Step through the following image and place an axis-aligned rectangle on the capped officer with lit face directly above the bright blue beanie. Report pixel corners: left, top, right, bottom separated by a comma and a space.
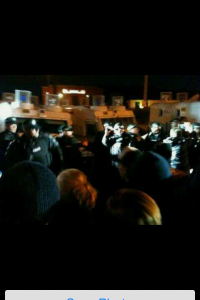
144, 122, 166, 151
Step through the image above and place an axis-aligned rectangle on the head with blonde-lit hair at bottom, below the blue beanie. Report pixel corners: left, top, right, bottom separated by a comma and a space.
106, 189, 162, 226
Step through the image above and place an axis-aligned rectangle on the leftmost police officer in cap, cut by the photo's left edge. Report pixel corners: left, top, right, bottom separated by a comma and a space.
0, 118, 18, 171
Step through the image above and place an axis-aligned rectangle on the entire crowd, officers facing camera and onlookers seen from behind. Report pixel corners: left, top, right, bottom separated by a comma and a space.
0, 118, 200, 228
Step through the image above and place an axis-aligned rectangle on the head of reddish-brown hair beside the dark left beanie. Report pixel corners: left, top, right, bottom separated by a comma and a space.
57, 169, 97, 210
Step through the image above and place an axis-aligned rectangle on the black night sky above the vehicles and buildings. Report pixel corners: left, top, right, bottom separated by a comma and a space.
0, 75, 200, 97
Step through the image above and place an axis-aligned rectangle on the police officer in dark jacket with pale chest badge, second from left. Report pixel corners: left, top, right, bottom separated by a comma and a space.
6, 119, 62, 175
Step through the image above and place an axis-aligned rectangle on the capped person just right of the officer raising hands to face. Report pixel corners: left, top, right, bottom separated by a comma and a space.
127, 124, 145, 151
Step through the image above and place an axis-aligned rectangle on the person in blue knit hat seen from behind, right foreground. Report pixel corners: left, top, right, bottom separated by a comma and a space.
127, 151, 173, 223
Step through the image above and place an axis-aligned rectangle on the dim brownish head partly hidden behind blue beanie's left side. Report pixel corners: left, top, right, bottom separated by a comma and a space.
118, 147, 142, 181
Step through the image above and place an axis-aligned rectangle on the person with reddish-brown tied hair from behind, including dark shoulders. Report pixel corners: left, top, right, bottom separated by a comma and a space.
45, 169, 97, 228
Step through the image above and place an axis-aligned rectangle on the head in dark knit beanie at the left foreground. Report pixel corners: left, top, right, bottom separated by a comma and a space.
0, 162, 60, 225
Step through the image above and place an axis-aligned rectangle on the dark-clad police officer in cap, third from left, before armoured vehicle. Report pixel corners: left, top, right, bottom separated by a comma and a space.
56, 125, 83, 170
